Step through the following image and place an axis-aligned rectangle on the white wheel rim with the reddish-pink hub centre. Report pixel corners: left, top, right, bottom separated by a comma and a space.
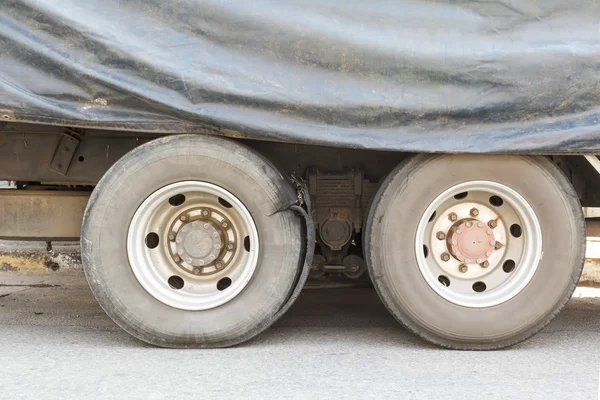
415, 181, 542, 308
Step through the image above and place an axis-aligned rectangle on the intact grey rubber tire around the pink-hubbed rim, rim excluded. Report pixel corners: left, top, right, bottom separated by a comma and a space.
364, 155, 585, 350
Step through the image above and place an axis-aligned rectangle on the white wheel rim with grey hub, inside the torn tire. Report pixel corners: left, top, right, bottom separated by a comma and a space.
127, 181, 259, 310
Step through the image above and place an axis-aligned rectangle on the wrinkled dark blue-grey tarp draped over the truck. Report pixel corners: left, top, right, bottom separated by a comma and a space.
0, 0, 600, 153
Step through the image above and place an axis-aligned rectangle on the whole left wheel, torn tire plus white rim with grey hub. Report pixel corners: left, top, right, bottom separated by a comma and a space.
81, 135, 305, 348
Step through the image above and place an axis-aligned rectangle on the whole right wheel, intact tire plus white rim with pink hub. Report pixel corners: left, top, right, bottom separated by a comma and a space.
364, 155, 585, 350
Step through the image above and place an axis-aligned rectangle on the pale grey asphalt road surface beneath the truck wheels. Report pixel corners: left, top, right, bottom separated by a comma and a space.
0, 273, 600, 400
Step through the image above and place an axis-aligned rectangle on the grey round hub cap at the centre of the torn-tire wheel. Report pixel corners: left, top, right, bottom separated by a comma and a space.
175, 221, 223, 266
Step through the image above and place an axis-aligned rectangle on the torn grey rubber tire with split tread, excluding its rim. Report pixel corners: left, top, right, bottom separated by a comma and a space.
81, 135, 304, 347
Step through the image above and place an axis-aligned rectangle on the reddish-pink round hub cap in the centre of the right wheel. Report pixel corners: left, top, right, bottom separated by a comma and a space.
446, 219, 496, 264
